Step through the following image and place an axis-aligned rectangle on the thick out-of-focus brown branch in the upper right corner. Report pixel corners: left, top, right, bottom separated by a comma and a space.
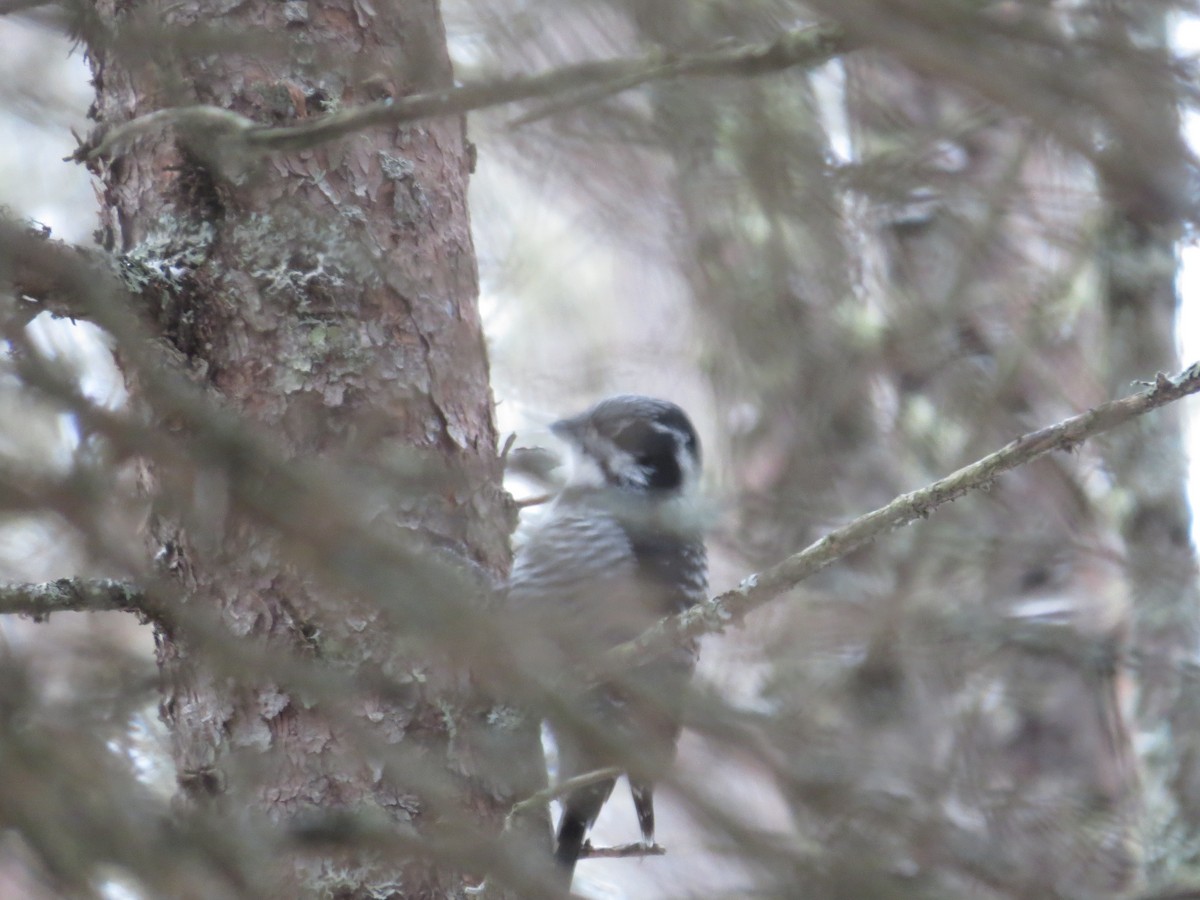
810, 0, 1196, 223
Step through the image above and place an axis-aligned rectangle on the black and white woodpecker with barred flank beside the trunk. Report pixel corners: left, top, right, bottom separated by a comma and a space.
509, 395, 708, 880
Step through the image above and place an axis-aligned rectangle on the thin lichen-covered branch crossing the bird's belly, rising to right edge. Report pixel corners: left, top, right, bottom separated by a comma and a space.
604, 362, 1200, 672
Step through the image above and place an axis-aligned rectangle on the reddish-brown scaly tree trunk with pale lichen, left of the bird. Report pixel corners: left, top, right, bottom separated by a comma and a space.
89, 0, 539, 898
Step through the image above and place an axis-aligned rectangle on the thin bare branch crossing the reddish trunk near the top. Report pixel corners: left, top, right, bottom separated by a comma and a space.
82, 26, 850, 162
